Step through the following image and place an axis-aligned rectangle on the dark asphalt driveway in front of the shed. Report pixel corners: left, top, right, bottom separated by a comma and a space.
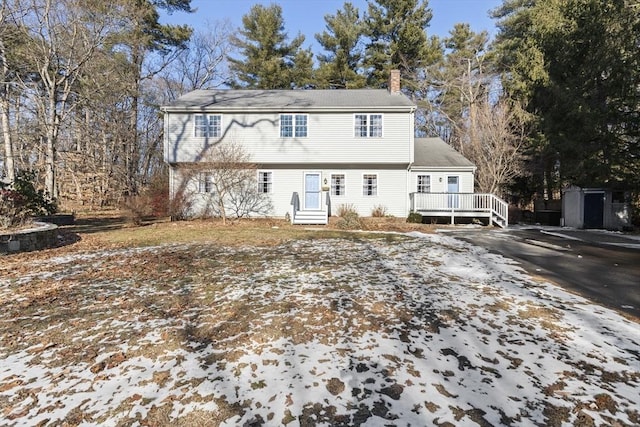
451, 226, 640, 317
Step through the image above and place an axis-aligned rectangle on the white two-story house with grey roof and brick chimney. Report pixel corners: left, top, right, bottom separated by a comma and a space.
162, 71, 506, 224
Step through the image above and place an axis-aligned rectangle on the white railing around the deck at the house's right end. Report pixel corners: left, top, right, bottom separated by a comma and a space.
410, 193, 509, 227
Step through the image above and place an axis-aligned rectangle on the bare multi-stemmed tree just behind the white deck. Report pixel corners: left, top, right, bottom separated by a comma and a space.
465, 99, 526, 197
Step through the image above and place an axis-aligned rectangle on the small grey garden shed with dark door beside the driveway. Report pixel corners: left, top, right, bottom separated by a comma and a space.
561, 186, 631, 230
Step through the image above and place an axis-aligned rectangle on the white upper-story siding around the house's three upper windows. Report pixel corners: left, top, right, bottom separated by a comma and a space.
165, 111, 413, 165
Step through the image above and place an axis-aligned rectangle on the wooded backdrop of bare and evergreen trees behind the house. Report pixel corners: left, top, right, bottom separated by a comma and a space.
0, 0, 640, 216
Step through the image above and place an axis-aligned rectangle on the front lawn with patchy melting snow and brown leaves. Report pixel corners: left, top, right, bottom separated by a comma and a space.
0, 234, 640, 426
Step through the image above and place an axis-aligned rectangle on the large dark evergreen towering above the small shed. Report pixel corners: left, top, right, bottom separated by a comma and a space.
495, 0, 640, 197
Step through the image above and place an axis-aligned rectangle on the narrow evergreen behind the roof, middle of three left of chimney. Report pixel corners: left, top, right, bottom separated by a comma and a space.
316, 2, 366, 89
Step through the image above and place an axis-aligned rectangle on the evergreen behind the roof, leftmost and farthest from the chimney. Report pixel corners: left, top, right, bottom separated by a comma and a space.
229, 4, 313, 89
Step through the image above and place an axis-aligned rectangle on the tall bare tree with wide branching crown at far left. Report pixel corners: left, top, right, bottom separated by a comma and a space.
13, 0, 116, 197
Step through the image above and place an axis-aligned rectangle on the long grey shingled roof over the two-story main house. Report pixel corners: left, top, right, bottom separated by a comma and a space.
162, 89, 415, 112
